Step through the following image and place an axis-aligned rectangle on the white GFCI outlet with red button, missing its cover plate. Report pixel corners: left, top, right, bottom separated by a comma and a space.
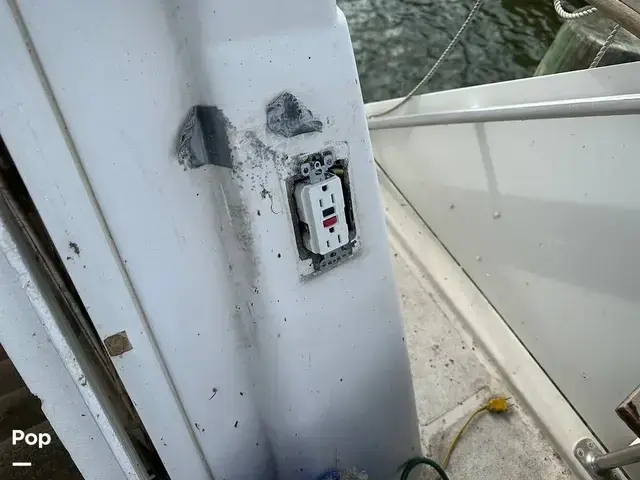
295, 175, 349, 255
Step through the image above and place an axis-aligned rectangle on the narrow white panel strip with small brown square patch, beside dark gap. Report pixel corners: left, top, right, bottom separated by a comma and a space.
0, 3, 222, 479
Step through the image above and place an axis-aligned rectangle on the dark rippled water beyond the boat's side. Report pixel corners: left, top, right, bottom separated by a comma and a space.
338, 0, 572, 102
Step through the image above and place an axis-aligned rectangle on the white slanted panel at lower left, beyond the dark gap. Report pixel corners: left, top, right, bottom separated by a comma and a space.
0, 200, 148, 480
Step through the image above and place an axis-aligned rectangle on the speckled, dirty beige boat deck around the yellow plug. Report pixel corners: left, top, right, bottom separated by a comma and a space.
382, 172, 576, 480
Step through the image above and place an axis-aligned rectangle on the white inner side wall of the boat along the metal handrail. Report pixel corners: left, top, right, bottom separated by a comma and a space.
371, 60, 640, 468
